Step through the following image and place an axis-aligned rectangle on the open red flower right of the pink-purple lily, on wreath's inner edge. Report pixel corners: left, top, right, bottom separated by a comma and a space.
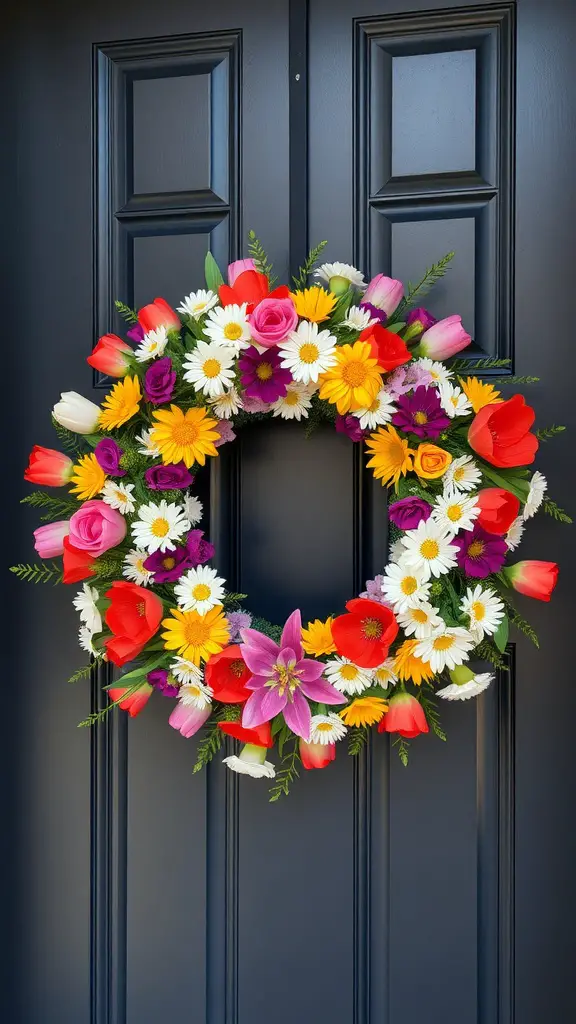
332, 597, 398, 669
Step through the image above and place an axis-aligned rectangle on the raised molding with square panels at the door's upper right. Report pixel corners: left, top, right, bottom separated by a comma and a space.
354, 3, 516, 375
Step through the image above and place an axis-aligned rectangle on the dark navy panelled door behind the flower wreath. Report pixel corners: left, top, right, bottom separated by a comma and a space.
0, 0, 576, 1024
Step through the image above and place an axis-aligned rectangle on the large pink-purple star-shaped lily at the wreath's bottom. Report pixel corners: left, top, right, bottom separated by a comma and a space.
240, 609, 346, 741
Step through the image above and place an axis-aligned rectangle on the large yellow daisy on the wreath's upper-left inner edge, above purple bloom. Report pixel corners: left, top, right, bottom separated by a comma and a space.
151, 406, 220, 469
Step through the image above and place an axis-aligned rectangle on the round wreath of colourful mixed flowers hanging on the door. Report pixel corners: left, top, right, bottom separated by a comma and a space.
12, 239, 571, 800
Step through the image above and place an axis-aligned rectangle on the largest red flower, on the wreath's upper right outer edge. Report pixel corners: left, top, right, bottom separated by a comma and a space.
468, 394, 538, 469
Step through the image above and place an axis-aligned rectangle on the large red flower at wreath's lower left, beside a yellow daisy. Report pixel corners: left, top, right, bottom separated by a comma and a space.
105, 581, 163, 666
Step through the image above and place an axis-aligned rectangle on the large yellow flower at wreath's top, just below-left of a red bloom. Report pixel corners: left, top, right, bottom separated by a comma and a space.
320, 341, 382, 416
